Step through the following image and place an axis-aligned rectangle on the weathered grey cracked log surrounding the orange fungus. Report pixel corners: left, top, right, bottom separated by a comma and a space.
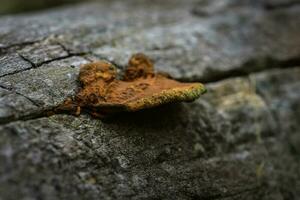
0, 0, 300, 200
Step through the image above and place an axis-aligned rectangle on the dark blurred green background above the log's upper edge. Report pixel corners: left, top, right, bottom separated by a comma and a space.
0, 0, 87, 15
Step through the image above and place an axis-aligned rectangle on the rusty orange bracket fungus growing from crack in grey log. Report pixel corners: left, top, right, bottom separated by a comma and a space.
58, 53, 206, 117
